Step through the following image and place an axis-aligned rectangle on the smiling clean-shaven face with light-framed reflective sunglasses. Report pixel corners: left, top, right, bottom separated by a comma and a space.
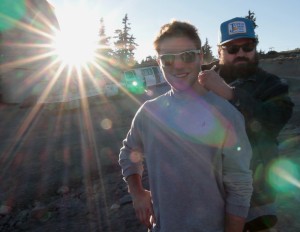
158, 37, 201, 91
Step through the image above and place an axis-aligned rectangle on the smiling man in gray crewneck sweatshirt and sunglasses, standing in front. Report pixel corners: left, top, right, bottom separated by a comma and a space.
119, 21, 252, 232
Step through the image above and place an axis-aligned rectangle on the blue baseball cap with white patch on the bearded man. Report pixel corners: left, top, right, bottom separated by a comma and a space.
218, 17, 256, 45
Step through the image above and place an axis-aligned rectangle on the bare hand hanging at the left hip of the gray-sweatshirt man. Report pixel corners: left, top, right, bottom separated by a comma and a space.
132, 190, 156, 228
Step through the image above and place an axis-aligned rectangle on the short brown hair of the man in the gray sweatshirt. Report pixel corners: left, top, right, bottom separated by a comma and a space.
153, 20, 201, 52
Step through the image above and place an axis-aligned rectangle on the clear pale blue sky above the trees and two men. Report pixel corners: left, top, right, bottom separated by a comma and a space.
48, 0, 300, 61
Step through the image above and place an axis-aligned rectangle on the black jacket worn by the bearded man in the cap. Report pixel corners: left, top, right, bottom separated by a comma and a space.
202, 62, 294, 207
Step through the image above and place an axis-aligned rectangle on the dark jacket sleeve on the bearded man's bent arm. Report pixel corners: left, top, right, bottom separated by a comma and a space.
231, 76, 294, 137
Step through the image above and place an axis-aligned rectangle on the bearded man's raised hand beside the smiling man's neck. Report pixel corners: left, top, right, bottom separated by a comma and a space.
198, 66, 233, 100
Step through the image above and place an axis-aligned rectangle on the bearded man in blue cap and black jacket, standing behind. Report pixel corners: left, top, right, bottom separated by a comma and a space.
198, 18, 294, 232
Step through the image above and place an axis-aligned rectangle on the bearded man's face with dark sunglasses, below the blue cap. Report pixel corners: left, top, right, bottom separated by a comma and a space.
218, 39, 256, 67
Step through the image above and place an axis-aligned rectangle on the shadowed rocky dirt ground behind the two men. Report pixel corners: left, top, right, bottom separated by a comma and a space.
0, 77, 300, 232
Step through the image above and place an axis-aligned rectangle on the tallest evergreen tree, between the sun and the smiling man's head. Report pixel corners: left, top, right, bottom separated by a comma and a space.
114, 14, 138, 68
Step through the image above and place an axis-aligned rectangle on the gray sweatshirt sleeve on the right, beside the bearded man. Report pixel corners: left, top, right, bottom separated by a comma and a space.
223, 111, 253, 217
